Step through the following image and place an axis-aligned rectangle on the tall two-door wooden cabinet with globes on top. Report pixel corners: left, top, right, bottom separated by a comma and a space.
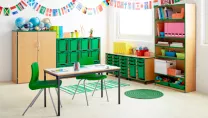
12, 31, 56, 84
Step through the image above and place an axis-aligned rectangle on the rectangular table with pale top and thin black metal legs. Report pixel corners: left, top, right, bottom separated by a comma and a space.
44, 64, 121, 116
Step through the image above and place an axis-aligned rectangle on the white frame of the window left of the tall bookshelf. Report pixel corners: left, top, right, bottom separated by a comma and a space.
115, 8, 155, 42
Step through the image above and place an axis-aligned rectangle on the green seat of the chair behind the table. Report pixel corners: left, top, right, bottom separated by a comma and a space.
76, 74, 107, 80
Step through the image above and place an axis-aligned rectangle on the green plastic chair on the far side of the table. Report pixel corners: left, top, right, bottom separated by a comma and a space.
72, 57, 109, 106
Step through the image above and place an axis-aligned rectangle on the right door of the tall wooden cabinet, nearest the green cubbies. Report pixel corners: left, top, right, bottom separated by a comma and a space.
38, 32, 56, 80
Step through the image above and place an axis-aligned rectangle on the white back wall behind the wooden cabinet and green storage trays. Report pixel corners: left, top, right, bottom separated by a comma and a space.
0, 0, 107, 81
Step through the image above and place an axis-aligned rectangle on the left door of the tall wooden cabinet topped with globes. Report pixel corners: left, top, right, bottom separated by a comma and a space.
18, 32, 37, 83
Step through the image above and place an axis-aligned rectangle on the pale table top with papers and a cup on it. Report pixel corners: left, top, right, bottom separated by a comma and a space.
44, 64, 120, 77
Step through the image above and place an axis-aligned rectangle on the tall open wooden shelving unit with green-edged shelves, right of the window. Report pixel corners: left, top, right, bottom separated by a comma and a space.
154, 4, 196, 92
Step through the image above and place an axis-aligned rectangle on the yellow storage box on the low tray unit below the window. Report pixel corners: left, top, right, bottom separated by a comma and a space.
113, 42, 132, 54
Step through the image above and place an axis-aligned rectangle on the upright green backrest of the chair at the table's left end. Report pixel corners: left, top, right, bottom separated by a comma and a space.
29, 62, 39, 89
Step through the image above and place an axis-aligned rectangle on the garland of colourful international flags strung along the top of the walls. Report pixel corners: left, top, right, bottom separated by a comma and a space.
0, 0, 184, 17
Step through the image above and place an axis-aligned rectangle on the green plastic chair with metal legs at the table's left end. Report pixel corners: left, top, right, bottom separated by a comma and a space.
22, 62, 62, 116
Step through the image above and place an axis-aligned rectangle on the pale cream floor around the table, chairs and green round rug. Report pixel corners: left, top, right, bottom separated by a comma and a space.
0, 77, 208, 118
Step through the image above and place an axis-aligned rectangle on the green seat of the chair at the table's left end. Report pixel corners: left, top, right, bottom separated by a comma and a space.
29, 80, 62, 90
